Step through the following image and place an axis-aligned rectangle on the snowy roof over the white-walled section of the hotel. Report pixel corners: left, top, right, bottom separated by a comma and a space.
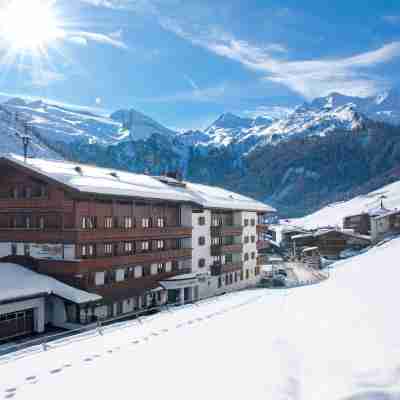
181, 182, 276, 212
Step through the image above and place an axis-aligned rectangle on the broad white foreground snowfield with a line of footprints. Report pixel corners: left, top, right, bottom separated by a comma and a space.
0, 239, 400, 400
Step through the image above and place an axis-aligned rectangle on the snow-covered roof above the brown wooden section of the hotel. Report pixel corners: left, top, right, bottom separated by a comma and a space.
1, 154, 194, 202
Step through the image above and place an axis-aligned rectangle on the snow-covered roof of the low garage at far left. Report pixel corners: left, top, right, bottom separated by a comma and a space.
0, 263, 101, 304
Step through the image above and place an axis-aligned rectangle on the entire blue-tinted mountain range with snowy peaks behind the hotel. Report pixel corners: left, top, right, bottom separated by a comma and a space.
0, 90, 400, 216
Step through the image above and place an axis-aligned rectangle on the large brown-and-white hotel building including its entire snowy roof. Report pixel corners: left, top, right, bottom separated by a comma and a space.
0, 155, 274, 332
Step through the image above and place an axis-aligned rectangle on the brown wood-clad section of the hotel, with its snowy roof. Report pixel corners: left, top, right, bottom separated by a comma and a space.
0, 156, 197, 323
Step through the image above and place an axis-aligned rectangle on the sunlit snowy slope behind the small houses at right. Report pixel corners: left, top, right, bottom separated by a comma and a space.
291, 181, 400, 229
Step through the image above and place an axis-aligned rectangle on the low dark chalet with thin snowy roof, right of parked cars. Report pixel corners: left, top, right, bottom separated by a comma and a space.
292, 229, 371, 259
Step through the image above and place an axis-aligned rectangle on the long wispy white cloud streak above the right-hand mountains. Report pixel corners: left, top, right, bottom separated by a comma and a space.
160, 18, 400, 98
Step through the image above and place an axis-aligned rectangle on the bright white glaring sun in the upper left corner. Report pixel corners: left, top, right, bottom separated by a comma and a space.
0, 0, 62, 52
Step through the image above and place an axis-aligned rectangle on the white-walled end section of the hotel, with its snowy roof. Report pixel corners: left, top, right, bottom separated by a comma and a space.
154, 177, 276, 298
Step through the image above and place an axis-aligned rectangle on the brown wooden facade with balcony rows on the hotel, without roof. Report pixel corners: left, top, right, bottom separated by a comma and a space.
0, 160, 192, 320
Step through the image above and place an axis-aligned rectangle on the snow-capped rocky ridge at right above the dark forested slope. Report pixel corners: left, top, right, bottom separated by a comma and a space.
182, 89, 400, 152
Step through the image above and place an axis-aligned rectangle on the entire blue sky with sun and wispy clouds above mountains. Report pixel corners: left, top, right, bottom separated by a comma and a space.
0, 0, 400, 129
